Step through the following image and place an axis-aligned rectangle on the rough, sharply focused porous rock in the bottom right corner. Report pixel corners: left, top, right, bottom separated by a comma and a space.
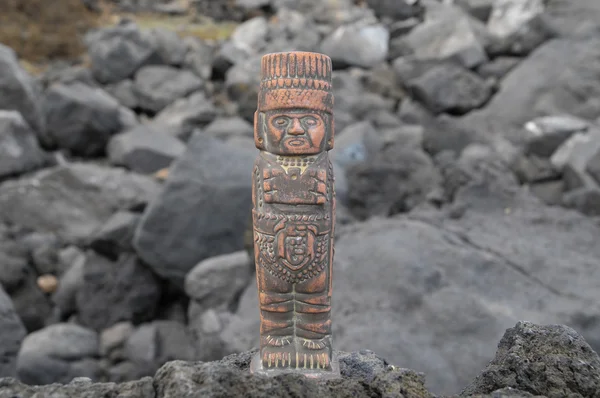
461, 322, 600, 398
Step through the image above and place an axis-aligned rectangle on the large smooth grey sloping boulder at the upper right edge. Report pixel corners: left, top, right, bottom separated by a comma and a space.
465, 35, 600, 134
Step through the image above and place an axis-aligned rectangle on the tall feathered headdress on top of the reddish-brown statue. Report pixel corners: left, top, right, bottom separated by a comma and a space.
258, 52, 333, 113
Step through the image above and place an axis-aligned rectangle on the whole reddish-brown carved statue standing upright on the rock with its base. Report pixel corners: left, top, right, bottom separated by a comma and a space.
251, 52, 339, 378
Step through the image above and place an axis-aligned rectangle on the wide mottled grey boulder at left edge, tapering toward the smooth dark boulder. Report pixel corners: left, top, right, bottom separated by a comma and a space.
0, 163, 160, 242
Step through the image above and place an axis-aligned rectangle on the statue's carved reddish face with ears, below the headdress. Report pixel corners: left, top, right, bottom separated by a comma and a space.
259, 110, 329, 155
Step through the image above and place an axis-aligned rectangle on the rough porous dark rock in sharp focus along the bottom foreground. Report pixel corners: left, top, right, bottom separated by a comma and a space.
0, 322, 600, 398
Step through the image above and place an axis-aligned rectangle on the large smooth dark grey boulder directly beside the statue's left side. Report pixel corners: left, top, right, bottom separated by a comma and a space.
134, 132, 256, 287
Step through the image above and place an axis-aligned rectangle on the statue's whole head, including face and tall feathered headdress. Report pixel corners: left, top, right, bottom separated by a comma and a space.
254, 52, 334, 155
